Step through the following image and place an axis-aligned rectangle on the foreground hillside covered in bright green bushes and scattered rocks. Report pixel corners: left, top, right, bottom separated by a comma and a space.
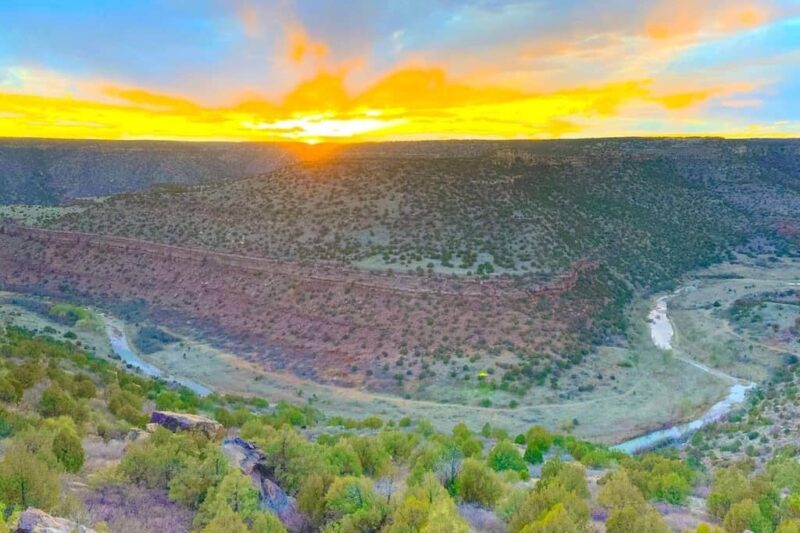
0, 304, 800, 533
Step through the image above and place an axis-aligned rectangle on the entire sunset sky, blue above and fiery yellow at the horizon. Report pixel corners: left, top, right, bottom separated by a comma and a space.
0, 0, 800, 143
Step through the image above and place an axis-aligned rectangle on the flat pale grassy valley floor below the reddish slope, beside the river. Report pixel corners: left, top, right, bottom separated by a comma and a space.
0, 286, 724, 444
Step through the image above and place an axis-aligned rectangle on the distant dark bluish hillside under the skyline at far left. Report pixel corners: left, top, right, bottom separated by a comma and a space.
0, 139, 290, 205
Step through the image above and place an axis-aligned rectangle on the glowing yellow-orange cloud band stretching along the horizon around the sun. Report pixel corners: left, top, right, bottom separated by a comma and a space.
0, 63, 768, 143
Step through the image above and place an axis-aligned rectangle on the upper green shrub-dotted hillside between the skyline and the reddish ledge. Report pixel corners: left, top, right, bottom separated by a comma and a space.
56, 139, 800, 287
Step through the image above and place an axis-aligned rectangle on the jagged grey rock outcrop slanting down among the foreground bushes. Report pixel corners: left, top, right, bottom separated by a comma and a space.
222, 437, 305, 531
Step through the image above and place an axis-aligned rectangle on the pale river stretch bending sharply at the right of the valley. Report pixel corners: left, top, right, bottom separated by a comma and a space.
613, 290, 755, 454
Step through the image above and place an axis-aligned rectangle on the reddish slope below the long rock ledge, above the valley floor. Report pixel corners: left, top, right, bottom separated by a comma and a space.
0, 226, 597, 390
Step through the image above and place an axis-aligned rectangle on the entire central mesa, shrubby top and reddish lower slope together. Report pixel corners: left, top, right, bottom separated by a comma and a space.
0, 139, 800, 405
